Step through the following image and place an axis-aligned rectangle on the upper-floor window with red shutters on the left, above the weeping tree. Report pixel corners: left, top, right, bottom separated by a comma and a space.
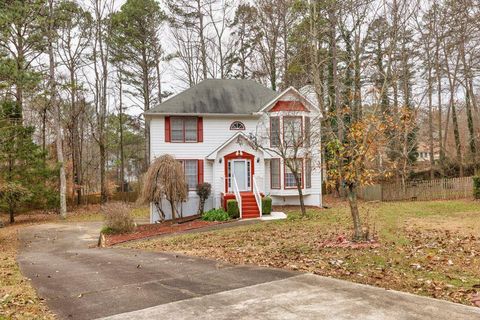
165, 117, 203, 142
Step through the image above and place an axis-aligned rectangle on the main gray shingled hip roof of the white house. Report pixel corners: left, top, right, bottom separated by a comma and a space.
145, 79, 279, 115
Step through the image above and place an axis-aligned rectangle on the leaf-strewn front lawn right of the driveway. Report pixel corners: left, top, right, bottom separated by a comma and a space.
126, 200, 480, 304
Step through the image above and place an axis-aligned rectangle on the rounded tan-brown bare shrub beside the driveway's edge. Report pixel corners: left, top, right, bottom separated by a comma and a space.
102, 202, 135, 234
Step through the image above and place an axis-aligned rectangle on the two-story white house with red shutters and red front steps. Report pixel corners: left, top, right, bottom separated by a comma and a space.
145, 80, 322, 222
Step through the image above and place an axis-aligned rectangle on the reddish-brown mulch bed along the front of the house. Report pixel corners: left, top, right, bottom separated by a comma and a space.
105, 219, 222, 246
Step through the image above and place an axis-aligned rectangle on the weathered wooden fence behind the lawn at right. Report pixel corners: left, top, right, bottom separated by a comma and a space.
358, 177, 473, 201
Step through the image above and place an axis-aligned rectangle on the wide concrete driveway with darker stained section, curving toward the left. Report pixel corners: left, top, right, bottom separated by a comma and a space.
18, 223, 480, 320
